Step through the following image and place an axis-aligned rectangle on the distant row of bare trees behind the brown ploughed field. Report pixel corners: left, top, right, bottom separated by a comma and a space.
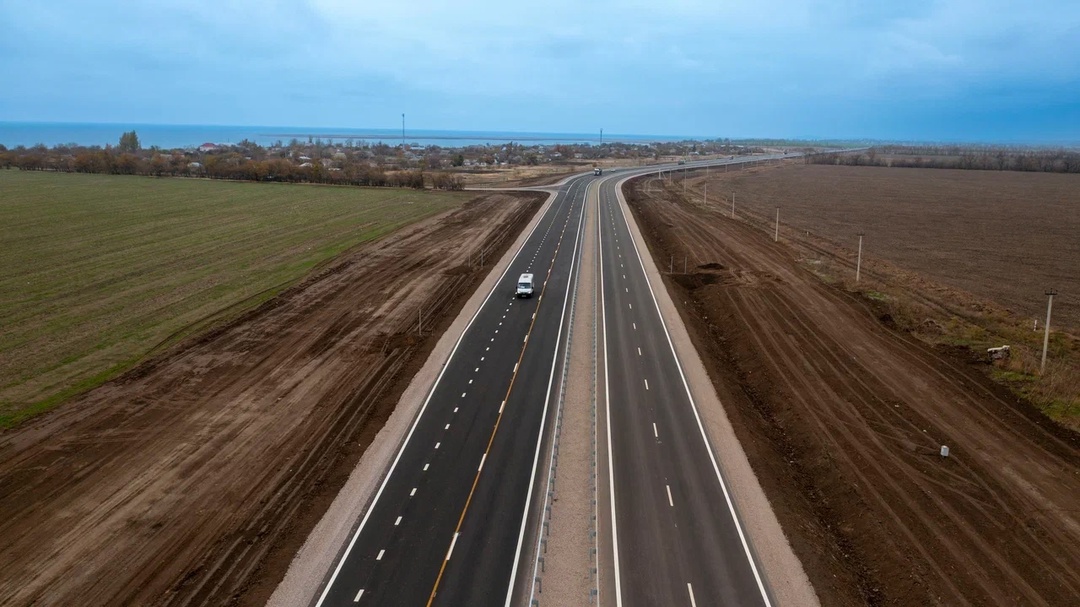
805, 146, 1080, 173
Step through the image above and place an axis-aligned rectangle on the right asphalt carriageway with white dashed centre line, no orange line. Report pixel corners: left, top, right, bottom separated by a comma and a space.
598, 171, 770, 606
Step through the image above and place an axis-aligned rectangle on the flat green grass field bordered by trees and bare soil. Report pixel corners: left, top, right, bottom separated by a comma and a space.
0, 170, 470, 428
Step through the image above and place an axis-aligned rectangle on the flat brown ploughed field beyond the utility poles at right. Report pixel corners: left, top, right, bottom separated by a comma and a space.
676, 164, 1080, 332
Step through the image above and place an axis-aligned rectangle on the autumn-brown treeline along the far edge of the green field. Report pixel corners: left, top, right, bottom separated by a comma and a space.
0, 146, 464, 190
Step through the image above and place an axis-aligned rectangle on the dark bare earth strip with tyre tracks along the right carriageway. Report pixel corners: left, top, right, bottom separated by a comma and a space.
627, 181, 1080, 606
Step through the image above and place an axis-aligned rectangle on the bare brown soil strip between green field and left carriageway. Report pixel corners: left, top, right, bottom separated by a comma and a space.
0, 193, 545, 605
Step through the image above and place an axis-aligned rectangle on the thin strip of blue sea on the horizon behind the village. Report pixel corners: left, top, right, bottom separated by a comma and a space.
0, 122, 686, 149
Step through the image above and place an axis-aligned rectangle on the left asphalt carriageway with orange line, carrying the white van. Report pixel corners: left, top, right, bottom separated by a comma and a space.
318, 171, 594, 606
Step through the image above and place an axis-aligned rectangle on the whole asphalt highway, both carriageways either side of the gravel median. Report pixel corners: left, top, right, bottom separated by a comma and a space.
315, 157, 790, 606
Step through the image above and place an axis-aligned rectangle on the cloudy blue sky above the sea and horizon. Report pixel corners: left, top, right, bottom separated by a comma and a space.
0, 0, 1080, 145
